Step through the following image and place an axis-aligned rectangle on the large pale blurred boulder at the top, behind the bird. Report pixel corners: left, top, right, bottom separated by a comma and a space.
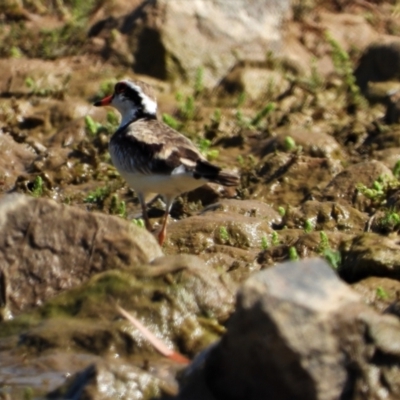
90, 0, 290, 87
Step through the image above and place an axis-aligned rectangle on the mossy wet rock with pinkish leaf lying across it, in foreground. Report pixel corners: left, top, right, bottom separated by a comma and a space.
0, 255, 236, 358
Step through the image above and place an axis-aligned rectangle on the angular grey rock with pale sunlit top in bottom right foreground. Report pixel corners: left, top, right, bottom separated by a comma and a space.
206, 259, 359, 400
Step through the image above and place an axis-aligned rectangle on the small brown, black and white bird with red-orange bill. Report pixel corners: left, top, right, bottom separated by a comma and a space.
94, 79, 239, 245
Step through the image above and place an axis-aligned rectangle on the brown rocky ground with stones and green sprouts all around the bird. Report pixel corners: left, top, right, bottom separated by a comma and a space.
0, 0, 400, 399
